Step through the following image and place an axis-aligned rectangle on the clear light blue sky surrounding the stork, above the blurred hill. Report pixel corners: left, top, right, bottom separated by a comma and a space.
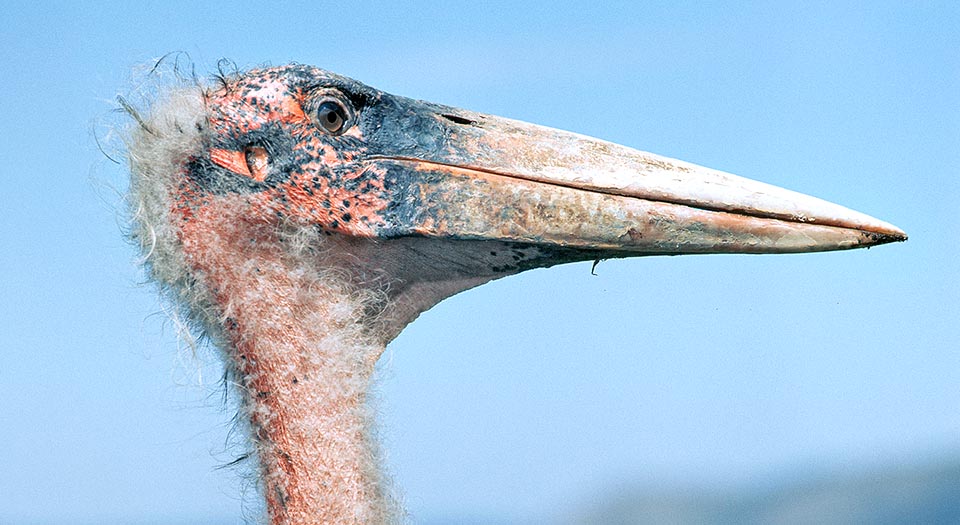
0, 1, 960, 523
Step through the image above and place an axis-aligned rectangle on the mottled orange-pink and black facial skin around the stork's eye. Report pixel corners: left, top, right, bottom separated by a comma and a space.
181, 68, 388, 237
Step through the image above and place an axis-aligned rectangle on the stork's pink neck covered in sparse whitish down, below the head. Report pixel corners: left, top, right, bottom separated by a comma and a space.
182, 203, 394, 524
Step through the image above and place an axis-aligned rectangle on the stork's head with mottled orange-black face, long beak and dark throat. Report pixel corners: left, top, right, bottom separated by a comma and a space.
133, 65, 906, 339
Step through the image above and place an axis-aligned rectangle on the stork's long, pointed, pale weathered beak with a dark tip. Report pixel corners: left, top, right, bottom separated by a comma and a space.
367, 101, 907, 256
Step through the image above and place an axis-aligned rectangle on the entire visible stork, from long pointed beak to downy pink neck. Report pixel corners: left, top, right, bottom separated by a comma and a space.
130, 65, 905, 524
